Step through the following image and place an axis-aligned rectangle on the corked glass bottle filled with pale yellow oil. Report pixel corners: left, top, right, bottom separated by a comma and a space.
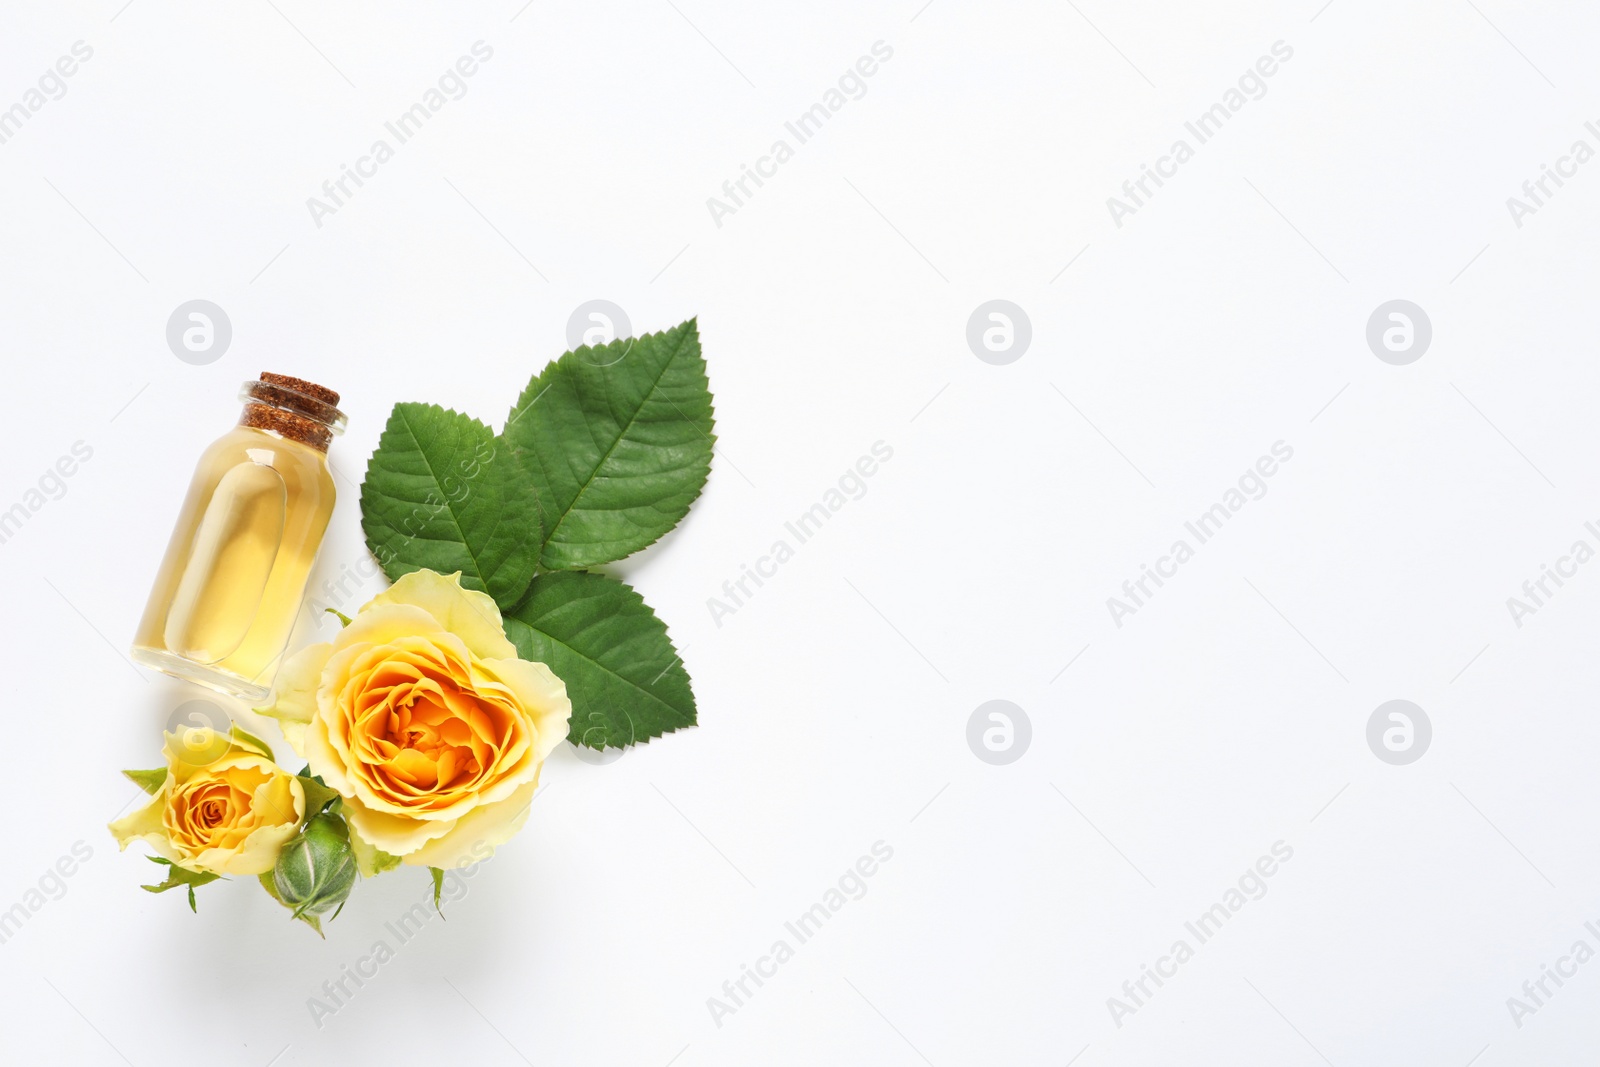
133, 374, 346, 702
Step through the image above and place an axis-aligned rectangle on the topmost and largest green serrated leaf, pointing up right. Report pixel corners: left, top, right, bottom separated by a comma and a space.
502, 318, 715, 571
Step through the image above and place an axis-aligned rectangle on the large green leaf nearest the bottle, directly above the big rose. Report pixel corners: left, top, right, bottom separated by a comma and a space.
362, 403, 542, 606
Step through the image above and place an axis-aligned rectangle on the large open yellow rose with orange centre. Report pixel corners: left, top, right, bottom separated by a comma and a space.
259, 569, 573, 869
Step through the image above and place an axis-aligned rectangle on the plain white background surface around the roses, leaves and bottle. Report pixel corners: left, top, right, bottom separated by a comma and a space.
0, 0, 1600, 1067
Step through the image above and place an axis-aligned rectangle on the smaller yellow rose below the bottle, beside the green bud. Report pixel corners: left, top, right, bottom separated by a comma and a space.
110, 726, 306, 875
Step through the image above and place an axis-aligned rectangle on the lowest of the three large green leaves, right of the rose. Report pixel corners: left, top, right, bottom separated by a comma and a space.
506, 571, 694, 749
